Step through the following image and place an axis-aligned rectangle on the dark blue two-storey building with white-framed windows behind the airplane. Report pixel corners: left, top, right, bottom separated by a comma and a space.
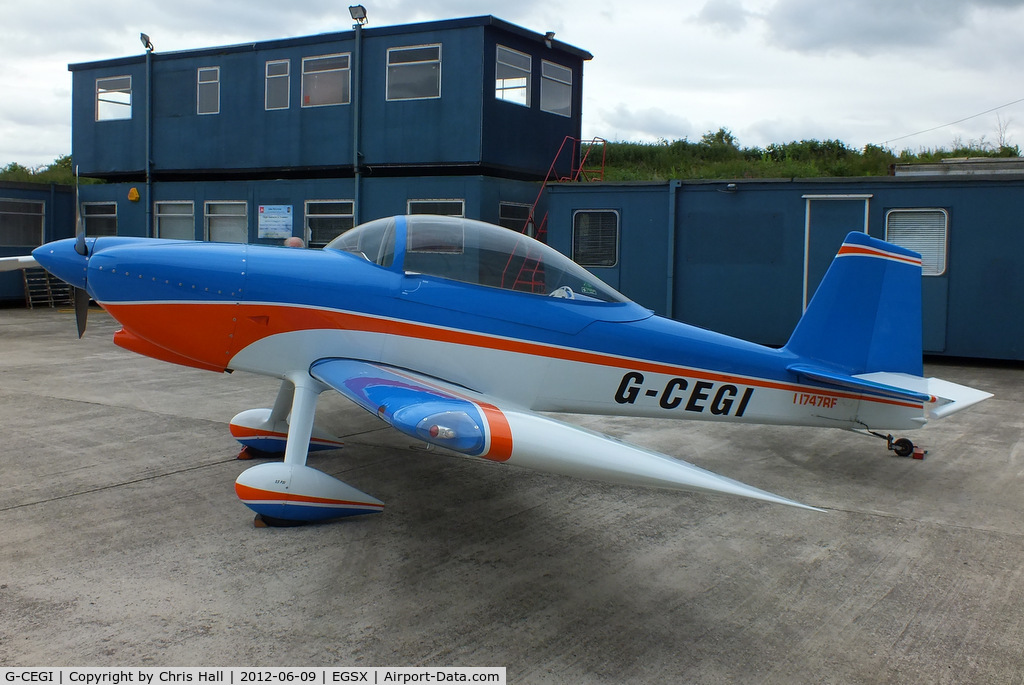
69, 16, 591, 246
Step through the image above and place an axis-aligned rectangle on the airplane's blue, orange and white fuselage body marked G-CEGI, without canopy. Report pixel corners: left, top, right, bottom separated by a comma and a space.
36, 239, 923, 429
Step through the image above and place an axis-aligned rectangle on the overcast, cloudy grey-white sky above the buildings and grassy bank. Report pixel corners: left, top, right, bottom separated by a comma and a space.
0, 0, 1024, 167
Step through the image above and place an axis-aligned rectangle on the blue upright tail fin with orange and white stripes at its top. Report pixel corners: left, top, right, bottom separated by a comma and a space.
785, 232, 923, 376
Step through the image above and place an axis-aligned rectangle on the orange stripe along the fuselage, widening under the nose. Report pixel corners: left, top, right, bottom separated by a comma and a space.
103, 301, 923, 411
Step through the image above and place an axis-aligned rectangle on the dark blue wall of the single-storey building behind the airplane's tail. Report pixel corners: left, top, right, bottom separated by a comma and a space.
549, 176, 1024, 360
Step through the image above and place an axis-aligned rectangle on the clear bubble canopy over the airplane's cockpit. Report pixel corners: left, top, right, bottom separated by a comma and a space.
324, 214, 629, 302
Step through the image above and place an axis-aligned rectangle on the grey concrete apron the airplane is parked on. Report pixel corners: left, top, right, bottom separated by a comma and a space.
0, 309, 1024, 683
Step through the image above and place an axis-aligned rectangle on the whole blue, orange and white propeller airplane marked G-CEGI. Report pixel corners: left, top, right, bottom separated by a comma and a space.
0, 215, 990, 524
